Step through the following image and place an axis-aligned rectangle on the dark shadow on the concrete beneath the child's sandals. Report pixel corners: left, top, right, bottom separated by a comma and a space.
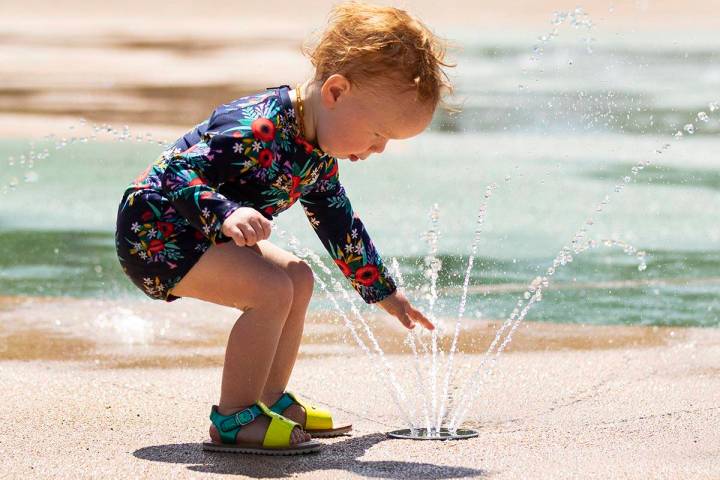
133, 433, 488, 480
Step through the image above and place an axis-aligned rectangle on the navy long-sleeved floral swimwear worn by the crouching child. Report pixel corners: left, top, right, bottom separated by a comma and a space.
115, 86, 395, 303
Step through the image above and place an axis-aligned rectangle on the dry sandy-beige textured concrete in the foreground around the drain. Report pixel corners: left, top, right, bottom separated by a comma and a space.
0, 320, 720, 479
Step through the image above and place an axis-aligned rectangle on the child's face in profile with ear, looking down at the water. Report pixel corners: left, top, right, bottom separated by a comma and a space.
317, 75, 434, 162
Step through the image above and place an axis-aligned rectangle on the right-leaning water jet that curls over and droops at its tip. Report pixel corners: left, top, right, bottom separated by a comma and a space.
448, 240, 647, 430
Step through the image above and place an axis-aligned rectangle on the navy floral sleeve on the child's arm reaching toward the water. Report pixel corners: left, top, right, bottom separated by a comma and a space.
300, 158, 396, 303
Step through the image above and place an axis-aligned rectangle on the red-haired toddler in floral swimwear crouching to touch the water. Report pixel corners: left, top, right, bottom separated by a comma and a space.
115, 2, 450, 454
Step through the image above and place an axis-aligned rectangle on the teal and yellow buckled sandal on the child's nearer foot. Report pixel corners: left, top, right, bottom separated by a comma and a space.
203, 402, 322, 455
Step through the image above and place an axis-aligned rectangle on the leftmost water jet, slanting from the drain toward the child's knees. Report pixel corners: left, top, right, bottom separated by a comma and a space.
275, 227, 416, 430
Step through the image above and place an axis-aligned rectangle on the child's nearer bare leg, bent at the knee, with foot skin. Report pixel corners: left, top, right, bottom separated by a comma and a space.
172, 243, 307, 442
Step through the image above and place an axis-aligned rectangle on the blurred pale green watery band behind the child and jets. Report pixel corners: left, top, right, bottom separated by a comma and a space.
0, 34, 720, 326
